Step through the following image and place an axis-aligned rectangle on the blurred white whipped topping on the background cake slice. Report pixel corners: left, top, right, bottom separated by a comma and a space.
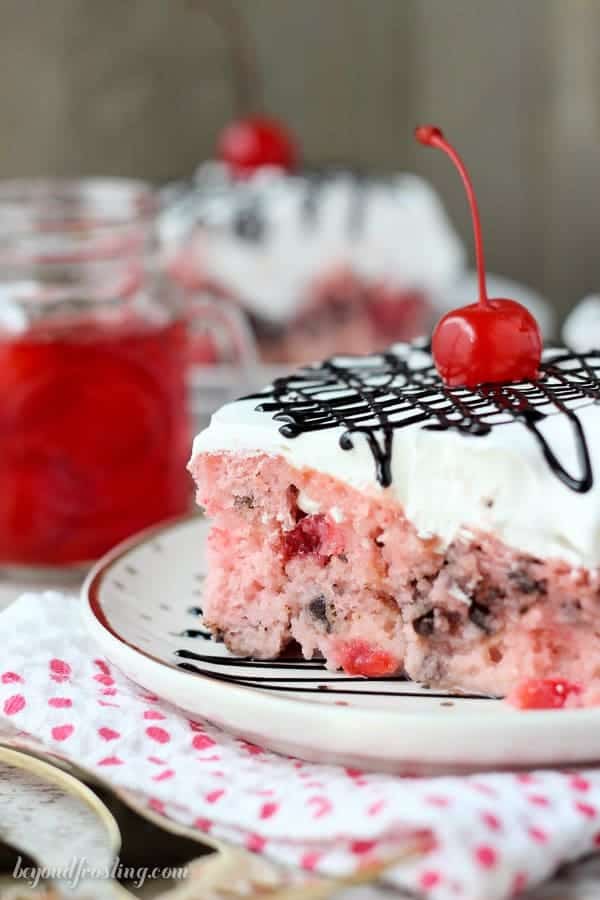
161, 163, 464, 324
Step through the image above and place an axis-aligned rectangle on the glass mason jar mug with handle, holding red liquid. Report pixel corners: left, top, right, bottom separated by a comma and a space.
0, 179, 253, 569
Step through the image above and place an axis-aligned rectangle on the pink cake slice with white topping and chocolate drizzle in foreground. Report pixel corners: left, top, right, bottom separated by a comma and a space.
190, 343, 600, 705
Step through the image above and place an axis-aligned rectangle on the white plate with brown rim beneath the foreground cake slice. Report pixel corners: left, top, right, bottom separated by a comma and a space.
83, 517, 600, 774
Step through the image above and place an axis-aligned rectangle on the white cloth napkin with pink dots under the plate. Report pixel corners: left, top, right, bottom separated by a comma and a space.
0, 593, 600, 900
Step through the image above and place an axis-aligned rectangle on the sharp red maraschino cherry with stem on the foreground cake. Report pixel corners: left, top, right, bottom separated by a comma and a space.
415, 125, 542, 388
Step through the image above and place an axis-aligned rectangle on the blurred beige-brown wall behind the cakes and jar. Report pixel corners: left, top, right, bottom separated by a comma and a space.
0, 0, 600, 320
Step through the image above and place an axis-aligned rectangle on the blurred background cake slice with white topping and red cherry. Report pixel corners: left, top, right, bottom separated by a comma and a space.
162, 120, 464, 363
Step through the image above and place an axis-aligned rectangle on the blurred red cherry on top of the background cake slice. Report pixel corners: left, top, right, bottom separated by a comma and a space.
217, 116, 298, 178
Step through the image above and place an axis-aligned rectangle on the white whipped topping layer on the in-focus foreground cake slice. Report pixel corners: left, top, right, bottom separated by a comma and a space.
193, 345, 600, 567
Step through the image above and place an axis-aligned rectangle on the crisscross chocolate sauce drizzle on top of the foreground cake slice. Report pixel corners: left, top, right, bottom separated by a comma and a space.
246, 343, 600, 493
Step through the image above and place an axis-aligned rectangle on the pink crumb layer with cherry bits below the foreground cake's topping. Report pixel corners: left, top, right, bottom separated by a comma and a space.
191, 453, 600, 696
